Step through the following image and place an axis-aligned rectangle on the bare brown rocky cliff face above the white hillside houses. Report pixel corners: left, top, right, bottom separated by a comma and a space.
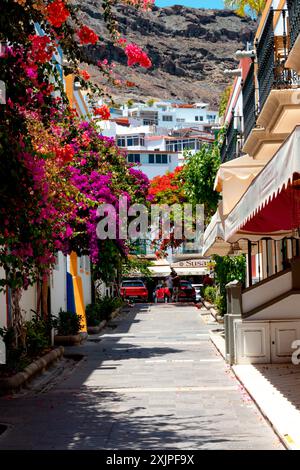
78, 0, 255, 107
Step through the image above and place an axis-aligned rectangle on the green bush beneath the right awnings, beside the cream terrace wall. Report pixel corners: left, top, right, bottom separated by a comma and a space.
212, 255, 246, 314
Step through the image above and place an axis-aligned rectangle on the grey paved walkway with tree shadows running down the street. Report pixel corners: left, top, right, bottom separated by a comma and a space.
0, 304, 282, 450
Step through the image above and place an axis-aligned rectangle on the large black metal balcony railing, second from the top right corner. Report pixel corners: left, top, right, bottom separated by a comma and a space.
256, 8, 300, 111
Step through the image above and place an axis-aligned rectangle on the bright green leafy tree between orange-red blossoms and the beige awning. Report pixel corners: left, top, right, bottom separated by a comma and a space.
183, 141, 221, 221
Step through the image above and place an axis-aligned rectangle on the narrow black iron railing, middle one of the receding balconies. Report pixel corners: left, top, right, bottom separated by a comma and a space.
243, 63, 256, 141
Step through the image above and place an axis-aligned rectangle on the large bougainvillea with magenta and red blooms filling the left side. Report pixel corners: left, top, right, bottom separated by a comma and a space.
0, 0, 153, 350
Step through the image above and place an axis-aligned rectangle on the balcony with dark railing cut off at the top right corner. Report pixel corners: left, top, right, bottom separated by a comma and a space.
286, 0, 300, 73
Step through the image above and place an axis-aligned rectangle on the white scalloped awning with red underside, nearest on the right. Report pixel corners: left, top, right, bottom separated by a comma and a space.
225, 126, 300, 241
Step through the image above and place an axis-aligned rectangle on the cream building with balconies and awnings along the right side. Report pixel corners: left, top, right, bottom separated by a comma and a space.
204, 0, 300, 363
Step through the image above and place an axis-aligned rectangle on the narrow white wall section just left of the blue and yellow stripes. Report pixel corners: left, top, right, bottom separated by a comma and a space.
50, 252, 67, 315
